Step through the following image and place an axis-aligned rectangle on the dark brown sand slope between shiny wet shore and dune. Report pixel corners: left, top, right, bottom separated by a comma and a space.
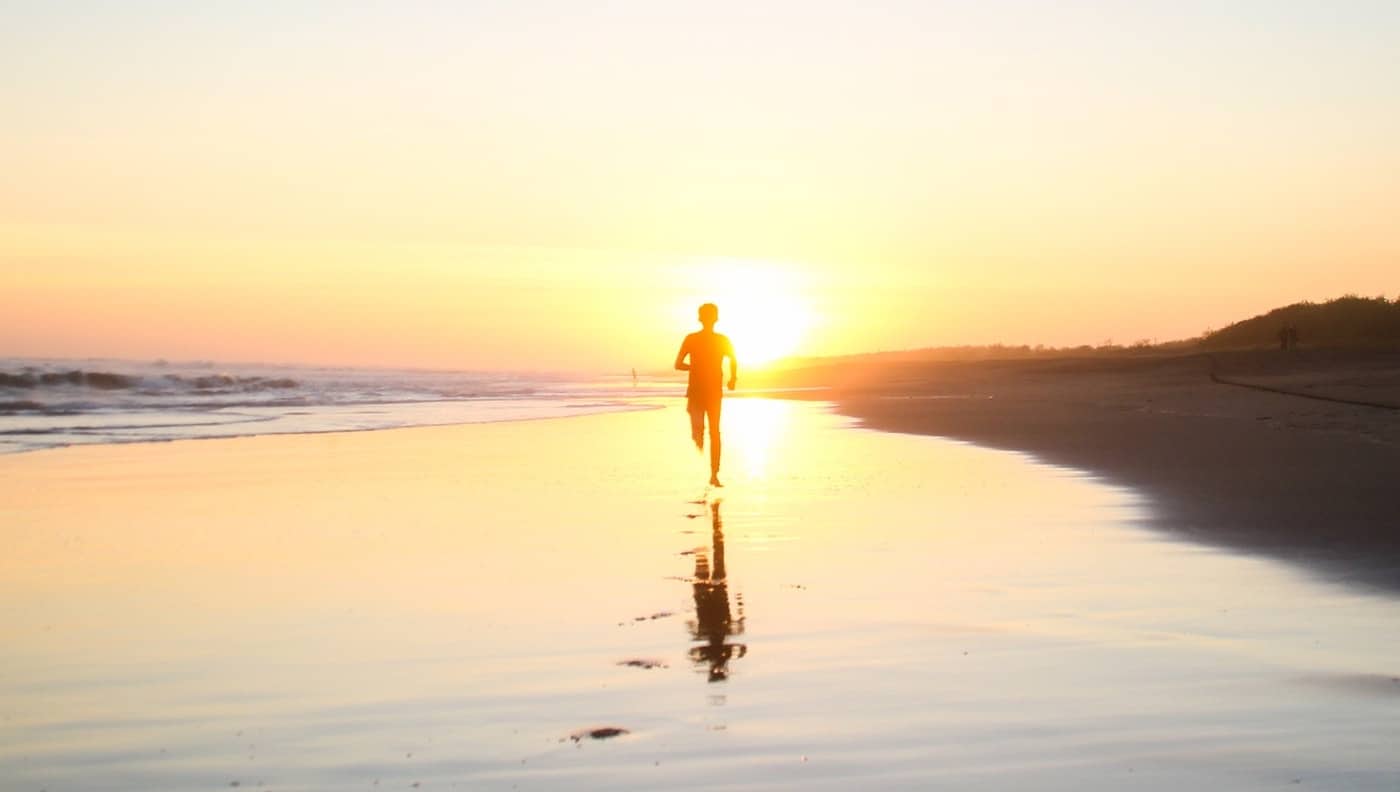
772, 350, 1400, 592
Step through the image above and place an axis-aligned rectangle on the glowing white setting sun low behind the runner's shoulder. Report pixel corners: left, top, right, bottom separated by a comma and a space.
674, 259, 813, 369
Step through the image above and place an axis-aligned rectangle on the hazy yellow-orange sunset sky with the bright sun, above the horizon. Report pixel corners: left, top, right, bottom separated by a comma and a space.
0, 0, 1400, 371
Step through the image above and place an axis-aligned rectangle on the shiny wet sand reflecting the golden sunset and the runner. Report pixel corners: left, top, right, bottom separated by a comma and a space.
0, 400, 1400, 791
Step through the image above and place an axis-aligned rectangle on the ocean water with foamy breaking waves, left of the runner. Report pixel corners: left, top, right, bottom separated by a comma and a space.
0, 358, 666, 453
